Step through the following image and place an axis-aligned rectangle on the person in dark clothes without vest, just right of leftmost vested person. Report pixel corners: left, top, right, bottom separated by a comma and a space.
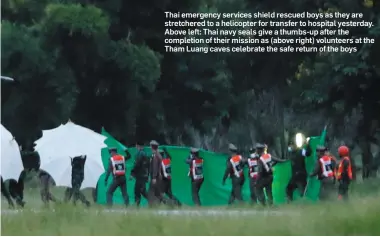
131, 142, 150, 206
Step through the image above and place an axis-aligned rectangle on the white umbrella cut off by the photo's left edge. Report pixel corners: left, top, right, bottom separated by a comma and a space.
1, 125, 24, 181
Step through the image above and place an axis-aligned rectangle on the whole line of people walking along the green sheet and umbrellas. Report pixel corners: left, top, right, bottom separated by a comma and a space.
1, 141, 352, 206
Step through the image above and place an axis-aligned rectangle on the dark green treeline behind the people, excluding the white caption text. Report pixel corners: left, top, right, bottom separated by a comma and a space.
1, 0, 380, 177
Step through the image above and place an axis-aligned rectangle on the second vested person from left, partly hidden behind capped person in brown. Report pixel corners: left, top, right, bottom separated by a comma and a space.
158, 148, 181, 206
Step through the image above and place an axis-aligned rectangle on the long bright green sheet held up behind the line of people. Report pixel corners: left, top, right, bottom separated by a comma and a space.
97, 130, 326, 206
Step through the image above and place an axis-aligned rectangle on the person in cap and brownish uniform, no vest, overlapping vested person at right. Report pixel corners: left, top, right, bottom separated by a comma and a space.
148, 140, 167, 206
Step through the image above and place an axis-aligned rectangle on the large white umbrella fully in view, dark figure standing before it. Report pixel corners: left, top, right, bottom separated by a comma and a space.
35, 121, 107, 189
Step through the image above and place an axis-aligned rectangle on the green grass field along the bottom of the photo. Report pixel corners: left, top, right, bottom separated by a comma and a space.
1, 180, 380, 235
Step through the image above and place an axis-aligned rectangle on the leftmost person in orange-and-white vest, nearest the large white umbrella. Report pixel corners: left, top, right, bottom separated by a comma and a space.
104, 148, 131, 206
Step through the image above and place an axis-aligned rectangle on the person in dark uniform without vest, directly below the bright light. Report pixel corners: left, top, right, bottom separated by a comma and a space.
286, 142, 311, 202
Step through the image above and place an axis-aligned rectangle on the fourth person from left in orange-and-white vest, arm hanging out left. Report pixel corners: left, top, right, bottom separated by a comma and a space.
222, 144, 245, 205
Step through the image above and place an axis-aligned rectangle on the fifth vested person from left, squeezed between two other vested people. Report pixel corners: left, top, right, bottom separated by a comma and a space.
246, 148, 259, 204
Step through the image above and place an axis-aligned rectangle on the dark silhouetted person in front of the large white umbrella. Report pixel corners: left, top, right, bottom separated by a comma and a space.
64, 156, 90, 207
